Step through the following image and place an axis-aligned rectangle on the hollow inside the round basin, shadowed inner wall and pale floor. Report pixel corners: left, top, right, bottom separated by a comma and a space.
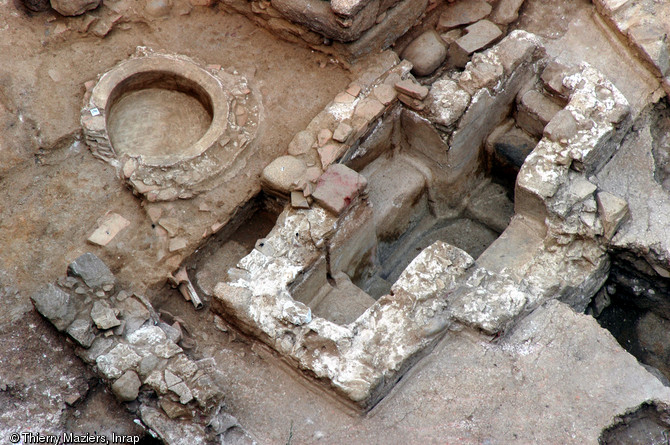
107, 71, 214, 162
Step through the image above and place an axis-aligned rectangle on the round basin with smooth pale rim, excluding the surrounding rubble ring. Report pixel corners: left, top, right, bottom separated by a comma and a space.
91, 55, 229, 167
